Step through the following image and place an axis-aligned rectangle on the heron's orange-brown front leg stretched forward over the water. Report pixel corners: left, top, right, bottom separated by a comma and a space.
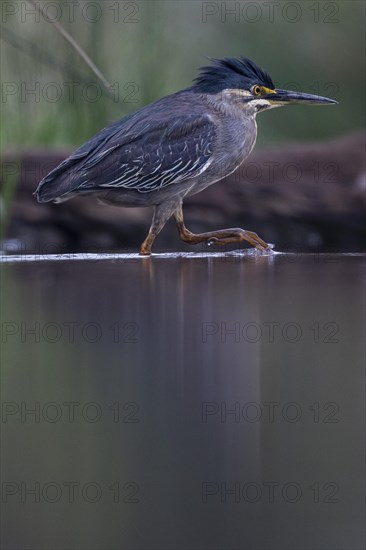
174, 205, 272, 250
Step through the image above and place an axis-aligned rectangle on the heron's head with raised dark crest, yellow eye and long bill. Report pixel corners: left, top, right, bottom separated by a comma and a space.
192, 57, 337, 114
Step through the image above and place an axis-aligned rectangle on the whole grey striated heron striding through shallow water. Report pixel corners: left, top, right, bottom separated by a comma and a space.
35, 57, 337, 255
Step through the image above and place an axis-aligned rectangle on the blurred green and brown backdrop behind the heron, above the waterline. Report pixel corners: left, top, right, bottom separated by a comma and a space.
1, 0, 366, 252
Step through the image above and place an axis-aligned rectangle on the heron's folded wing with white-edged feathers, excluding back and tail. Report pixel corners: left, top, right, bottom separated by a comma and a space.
78, 115, 215, 193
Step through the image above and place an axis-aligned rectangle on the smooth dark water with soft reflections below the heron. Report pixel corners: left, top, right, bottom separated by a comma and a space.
1, 256, 365, 550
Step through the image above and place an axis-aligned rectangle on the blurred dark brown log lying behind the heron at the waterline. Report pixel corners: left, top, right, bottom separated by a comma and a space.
0, 133, 366, 253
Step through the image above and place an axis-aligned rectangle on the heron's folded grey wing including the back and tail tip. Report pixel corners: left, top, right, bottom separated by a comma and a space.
36, 109, 215, 202
